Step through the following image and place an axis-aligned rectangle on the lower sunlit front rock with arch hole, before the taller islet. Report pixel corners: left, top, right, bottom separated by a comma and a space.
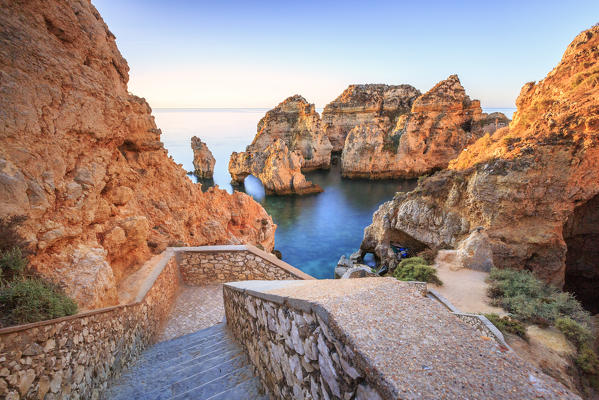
229, 139, 322, 195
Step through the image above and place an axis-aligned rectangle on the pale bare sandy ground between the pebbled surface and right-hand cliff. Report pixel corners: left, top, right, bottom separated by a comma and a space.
431, 263, 506, 315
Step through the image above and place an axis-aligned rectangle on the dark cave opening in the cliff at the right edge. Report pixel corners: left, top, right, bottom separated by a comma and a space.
563, 195, 599, 314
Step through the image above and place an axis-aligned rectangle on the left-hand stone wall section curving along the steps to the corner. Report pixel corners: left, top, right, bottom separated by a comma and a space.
0, 254, 179, 400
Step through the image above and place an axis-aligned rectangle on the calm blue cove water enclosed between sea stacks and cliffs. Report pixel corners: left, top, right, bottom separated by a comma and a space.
236, 165, 416, 278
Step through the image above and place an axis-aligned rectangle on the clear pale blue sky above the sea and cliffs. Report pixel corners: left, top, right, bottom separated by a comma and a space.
92, 0, 599, 108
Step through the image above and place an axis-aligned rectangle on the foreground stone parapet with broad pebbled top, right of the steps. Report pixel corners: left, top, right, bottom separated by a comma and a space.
224, 278, 579, 400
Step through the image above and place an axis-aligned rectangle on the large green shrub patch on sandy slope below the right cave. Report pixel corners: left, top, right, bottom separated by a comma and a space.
488, 268, 590, 326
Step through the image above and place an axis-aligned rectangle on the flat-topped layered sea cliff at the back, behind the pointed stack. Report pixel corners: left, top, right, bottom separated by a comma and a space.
322, 84, 420, 152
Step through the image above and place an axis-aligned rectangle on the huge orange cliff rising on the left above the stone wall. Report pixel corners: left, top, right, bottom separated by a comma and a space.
0, 0, 275, 308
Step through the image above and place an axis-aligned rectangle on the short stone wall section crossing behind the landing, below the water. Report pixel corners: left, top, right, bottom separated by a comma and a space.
174, 245, 314, 285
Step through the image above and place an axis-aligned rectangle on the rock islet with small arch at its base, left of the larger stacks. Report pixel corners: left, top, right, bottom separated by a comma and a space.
229, 95, 332, 194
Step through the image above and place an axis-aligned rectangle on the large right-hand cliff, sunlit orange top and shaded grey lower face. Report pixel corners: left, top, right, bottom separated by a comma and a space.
362, 26, 599, 291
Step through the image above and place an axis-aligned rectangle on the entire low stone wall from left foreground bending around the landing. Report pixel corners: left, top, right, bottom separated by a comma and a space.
0, 246, 314, 399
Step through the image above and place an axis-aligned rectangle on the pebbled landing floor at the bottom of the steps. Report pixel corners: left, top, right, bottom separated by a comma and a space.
159, 284, 225, 341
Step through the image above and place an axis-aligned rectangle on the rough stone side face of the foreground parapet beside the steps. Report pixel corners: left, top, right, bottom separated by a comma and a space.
224, 285, 382, 400
